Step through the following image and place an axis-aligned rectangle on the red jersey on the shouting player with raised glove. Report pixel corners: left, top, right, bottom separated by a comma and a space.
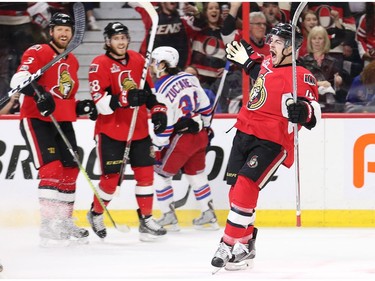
235, 56, 318, 167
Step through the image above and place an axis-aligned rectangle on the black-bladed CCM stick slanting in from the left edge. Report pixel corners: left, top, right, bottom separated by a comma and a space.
0, 2, 86, 108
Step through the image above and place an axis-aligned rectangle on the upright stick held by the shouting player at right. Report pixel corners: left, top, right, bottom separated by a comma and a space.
292, 2, 307, 227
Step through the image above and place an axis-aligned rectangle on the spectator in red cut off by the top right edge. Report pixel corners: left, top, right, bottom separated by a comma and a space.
356, 2, 375, 66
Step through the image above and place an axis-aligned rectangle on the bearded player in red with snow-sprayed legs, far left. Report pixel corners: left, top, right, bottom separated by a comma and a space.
11, 13, 96, 246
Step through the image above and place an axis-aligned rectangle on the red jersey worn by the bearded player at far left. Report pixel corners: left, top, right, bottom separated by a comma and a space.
18, 44, 79, 121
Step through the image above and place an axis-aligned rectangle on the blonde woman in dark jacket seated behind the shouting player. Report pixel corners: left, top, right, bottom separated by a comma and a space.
300, 26, 350, 112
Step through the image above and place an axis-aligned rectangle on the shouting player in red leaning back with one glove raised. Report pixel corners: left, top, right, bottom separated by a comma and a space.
211, 23, 321, 271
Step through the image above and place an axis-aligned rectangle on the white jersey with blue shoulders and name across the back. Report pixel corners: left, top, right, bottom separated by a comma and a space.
152, 72, 212, 147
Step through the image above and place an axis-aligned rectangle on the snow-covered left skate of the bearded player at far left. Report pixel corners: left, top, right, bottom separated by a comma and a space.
39, 219, 70, 248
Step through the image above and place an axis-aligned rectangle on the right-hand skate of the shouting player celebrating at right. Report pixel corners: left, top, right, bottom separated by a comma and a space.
225, 228, 258, 271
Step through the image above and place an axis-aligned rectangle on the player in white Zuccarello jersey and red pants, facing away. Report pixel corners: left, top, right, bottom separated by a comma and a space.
151, 46, 219, 231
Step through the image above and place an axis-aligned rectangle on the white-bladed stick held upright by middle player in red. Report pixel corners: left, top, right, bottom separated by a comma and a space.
117, 2, 159, 190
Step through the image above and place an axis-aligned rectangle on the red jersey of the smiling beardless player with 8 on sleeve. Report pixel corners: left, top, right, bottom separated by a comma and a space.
89, 50, 154, 141
